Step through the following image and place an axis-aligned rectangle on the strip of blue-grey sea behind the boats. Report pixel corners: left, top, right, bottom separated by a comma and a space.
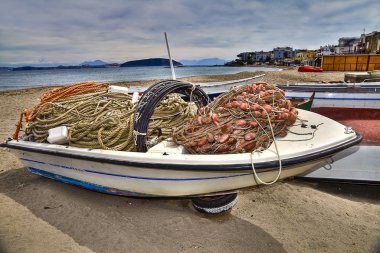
0, 66, 278, 90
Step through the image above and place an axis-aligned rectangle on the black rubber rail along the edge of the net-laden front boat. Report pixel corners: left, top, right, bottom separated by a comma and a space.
0, 133, 363, 171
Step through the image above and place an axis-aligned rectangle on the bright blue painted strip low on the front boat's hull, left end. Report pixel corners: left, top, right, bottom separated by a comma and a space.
28, 167, 156, 197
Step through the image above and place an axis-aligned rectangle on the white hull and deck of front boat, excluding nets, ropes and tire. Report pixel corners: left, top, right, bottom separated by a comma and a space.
1, 110, 361, 197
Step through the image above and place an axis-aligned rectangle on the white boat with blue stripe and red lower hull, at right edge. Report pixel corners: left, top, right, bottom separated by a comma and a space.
277, 82, 380, 145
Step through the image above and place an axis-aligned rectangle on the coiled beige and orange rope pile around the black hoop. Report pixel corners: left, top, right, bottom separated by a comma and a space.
14, 82, 193, 151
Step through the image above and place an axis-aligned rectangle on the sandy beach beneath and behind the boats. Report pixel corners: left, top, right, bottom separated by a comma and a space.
0, 69, 380, 253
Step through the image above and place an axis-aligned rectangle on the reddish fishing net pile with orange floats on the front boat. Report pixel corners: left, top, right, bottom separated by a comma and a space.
173, 82, 298, 154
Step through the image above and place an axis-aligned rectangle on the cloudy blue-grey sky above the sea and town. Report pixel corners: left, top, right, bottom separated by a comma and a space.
0, 0, 380, 66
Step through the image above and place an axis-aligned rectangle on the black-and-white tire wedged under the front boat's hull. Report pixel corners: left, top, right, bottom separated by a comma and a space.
191, 193, 237, 214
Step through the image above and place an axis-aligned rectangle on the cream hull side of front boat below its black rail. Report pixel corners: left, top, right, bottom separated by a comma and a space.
12, 151, 327, 197
